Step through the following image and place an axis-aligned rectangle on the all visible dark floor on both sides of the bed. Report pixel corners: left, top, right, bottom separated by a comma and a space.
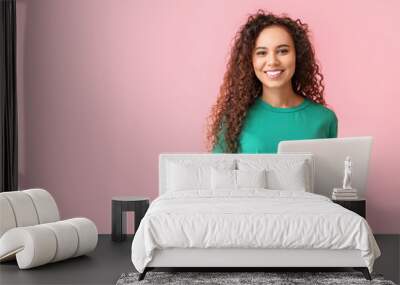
0, 235, 400, 285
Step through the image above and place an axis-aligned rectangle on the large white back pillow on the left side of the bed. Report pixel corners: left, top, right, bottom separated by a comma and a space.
166, 159, 235, 191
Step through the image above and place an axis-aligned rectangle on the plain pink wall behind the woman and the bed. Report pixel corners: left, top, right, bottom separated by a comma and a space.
17, 0, 400, 233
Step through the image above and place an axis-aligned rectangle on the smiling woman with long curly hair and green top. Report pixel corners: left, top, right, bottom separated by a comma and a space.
207, 10, 337, 153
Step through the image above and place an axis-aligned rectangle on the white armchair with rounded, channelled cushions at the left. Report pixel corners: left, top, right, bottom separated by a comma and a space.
0, 189, 98, 269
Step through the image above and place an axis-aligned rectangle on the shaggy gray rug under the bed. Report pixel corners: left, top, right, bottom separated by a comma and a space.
117, 271, 395, 285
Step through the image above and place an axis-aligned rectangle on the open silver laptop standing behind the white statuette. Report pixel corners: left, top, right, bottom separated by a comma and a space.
278, 137, 372, 198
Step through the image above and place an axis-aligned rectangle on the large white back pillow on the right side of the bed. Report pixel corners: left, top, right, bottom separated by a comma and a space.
238, 159, 311, 192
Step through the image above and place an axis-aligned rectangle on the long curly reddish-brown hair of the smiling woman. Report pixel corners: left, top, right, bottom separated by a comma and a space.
206, 10, 326, 153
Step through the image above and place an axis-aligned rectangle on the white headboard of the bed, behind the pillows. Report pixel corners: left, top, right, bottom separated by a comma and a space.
158, 153, 315, 195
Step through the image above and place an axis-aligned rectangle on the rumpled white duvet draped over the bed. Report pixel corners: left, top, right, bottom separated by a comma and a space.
132, 189, 380, 272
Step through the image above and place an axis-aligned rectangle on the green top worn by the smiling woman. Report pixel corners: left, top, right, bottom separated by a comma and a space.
212, 97, 337, 153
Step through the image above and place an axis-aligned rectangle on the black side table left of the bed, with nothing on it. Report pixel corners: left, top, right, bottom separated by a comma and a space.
111, 196, 150, 241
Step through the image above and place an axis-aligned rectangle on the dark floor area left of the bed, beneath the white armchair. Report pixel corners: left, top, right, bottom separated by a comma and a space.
0, 235, 134, 285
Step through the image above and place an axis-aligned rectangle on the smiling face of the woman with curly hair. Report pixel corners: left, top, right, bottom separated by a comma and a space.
252, 25, 296, 88
